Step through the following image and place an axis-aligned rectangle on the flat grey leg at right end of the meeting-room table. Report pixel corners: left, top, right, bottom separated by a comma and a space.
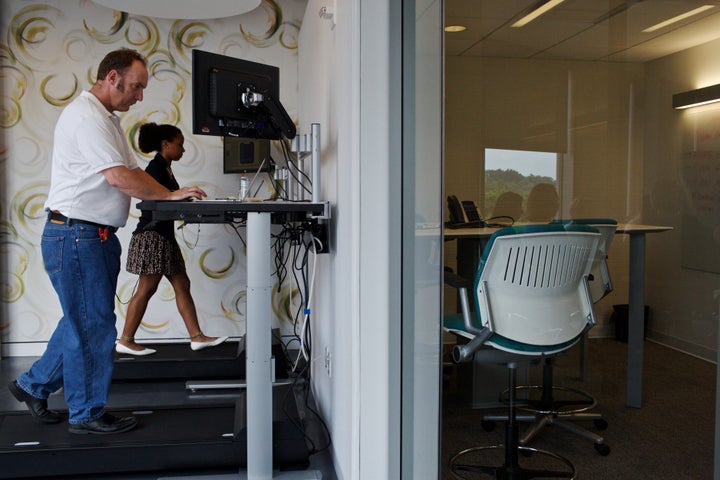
627, 233, 645, 408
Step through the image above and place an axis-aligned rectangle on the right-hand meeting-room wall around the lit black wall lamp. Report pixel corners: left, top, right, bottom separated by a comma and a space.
643, 40, 720, 359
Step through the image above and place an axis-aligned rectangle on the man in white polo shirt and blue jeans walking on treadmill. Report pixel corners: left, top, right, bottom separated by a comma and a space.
8, 48, 205, 434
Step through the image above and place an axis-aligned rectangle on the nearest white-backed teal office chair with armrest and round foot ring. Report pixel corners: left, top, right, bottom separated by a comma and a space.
444, 225, 600, 480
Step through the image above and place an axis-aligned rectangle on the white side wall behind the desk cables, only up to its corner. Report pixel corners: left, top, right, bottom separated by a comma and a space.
298, 0, 359, 479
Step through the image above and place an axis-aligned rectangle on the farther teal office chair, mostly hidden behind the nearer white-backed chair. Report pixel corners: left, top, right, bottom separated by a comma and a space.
482, 218, 617, 455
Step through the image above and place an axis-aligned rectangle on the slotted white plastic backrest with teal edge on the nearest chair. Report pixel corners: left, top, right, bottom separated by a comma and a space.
474, 224, 600, 355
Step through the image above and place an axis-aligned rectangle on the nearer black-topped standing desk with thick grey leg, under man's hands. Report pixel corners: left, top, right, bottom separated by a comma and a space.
137, 200, 329, 480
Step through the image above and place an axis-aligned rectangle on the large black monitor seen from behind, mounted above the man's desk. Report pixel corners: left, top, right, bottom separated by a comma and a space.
192, 49, 295, 140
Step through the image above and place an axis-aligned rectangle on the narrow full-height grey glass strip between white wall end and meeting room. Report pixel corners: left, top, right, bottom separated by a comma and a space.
401, 0, 443, 480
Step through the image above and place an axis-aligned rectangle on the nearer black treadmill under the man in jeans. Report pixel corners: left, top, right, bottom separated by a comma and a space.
0, 380, 310, 479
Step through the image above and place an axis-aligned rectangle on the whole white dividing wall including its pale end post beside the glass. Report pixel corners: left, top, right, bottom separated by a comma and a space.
299, 0, 410, 479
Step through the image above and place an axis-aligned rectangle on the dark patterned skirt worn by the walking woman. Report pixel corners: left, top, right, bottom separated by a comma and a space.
125, 231, 185, 275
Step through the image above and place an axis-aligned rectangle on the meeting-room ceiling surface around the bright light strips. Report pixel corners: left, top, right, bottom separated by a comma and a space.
445, 0, 720, 62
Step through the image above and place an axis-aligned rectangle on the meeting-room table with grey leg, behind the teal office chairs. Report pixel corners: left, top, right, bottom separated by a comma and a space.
444, 224, 672, 408
